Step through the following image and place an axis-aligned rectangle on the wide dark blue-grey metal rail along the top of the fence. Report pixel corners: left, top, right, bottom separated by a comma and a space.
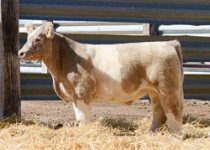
20, 0, 210, 25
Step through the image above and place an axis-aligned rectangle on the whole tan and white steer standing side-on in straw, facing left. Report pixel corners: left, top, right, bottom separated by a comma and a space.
18, 22, 183, 132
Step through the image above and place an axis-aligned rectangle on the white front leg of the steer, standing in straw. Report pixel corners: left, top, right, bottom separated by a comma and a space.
73, 100, 91, 123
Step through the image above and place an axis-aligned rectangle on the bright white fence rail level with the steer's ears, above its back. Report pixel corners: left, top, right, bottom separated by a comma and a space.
19, 19, 210, 37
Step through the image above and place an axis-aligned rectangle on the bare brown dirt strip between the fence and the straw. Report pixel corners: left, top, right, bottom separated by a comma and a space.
21, 100, 210, 124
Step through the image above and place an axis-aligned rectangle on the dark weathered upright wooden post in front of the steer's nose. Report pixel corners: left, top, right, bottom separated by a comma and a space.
0, 0, 20, 118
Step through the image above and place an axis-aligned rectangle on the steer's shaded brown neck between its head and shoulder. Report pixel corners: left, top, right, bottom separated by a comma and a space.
43, 33, 88, 81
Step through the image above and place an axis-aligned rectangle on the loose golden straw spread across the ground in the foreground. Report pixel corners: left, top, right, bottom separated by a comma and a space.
0, 118, 210, 150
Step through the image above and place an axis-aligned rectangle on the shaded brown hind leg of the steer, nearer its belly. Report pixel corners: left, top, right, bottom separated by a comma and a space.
150, 96, 166, 132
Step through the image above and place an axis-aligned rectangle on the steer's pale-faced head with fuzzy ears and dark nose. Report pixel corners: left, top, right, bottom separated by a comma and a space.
18, 22, 54, 60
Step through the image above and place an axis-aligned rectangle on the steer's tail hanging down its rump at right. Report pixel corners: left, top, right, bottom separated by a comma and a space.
170, 40, 184, 83
